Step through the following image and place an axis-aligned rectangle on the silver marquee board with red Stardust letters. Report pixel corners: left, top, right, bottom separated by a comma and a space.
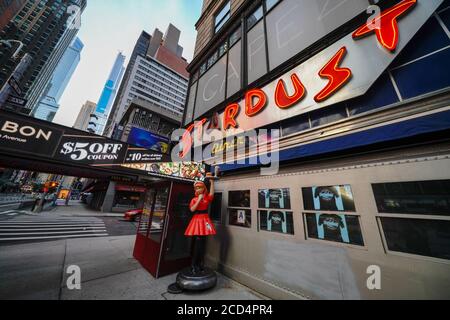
181, 0, 443, 157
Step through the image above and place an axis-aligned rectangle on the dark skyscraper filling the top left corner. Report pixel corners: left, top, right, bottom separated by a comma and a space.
0, 0, 87, 114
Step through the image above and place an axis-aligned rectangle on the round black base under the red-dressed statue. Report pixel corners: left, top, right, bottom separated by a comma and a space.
168, 268, 217, 294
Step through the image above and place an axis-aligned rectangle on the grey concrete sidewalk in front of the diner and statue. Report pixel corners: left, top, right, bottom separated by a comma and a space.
0, 236, 264, 300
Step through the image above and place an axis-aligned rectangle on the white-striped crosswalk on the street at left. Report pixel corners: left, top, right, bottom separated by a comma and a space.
0, 216, 109, 243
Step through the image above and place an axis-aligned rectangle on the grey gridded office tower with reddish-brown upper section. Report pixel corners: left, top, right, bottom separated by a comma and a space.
105, 24, 189, 138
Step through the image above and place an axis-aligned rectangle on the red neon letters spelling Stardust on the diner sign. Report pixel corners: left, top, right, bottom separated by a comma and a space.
180, 0, 418, 158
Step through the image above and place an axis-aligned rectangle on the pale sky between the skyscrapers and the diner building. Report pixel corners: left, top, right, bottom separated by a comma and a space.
54, 0, 202, 127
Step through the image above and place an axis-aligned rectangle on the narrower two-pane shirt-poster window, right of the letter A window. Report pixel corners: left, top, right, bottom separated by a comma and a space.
258, 189, 294, 234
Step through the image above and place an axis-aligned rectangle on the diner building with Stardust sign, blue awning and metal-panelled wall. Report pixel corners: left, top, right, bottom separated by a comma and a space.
183, 0, 450, 299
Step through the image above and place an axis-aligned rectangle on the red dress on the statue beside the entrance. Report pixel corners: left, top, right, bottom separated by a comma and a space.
184, 194, 217, 237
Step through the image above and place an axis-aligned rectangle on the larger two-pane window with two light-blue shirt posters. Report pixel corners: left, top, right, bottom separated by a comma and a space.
302, 185, 364, 246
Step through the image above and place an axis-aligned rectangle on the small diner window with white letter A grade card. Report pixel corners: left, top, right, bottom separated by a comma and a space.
228, 190, 252, 228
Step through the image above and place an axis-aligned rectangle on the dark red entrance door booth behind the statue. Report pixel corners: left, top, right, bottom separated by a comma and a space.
134, 182, 193, 278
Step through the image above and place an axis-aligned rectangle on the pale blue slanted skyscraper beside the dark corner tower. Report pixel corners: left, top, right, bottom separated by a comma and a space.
33, 38, 84, 121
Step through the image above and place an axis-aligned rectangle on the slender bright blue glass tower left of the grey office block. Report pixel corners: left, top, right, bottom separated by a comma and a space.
88, 53, 125, 135
